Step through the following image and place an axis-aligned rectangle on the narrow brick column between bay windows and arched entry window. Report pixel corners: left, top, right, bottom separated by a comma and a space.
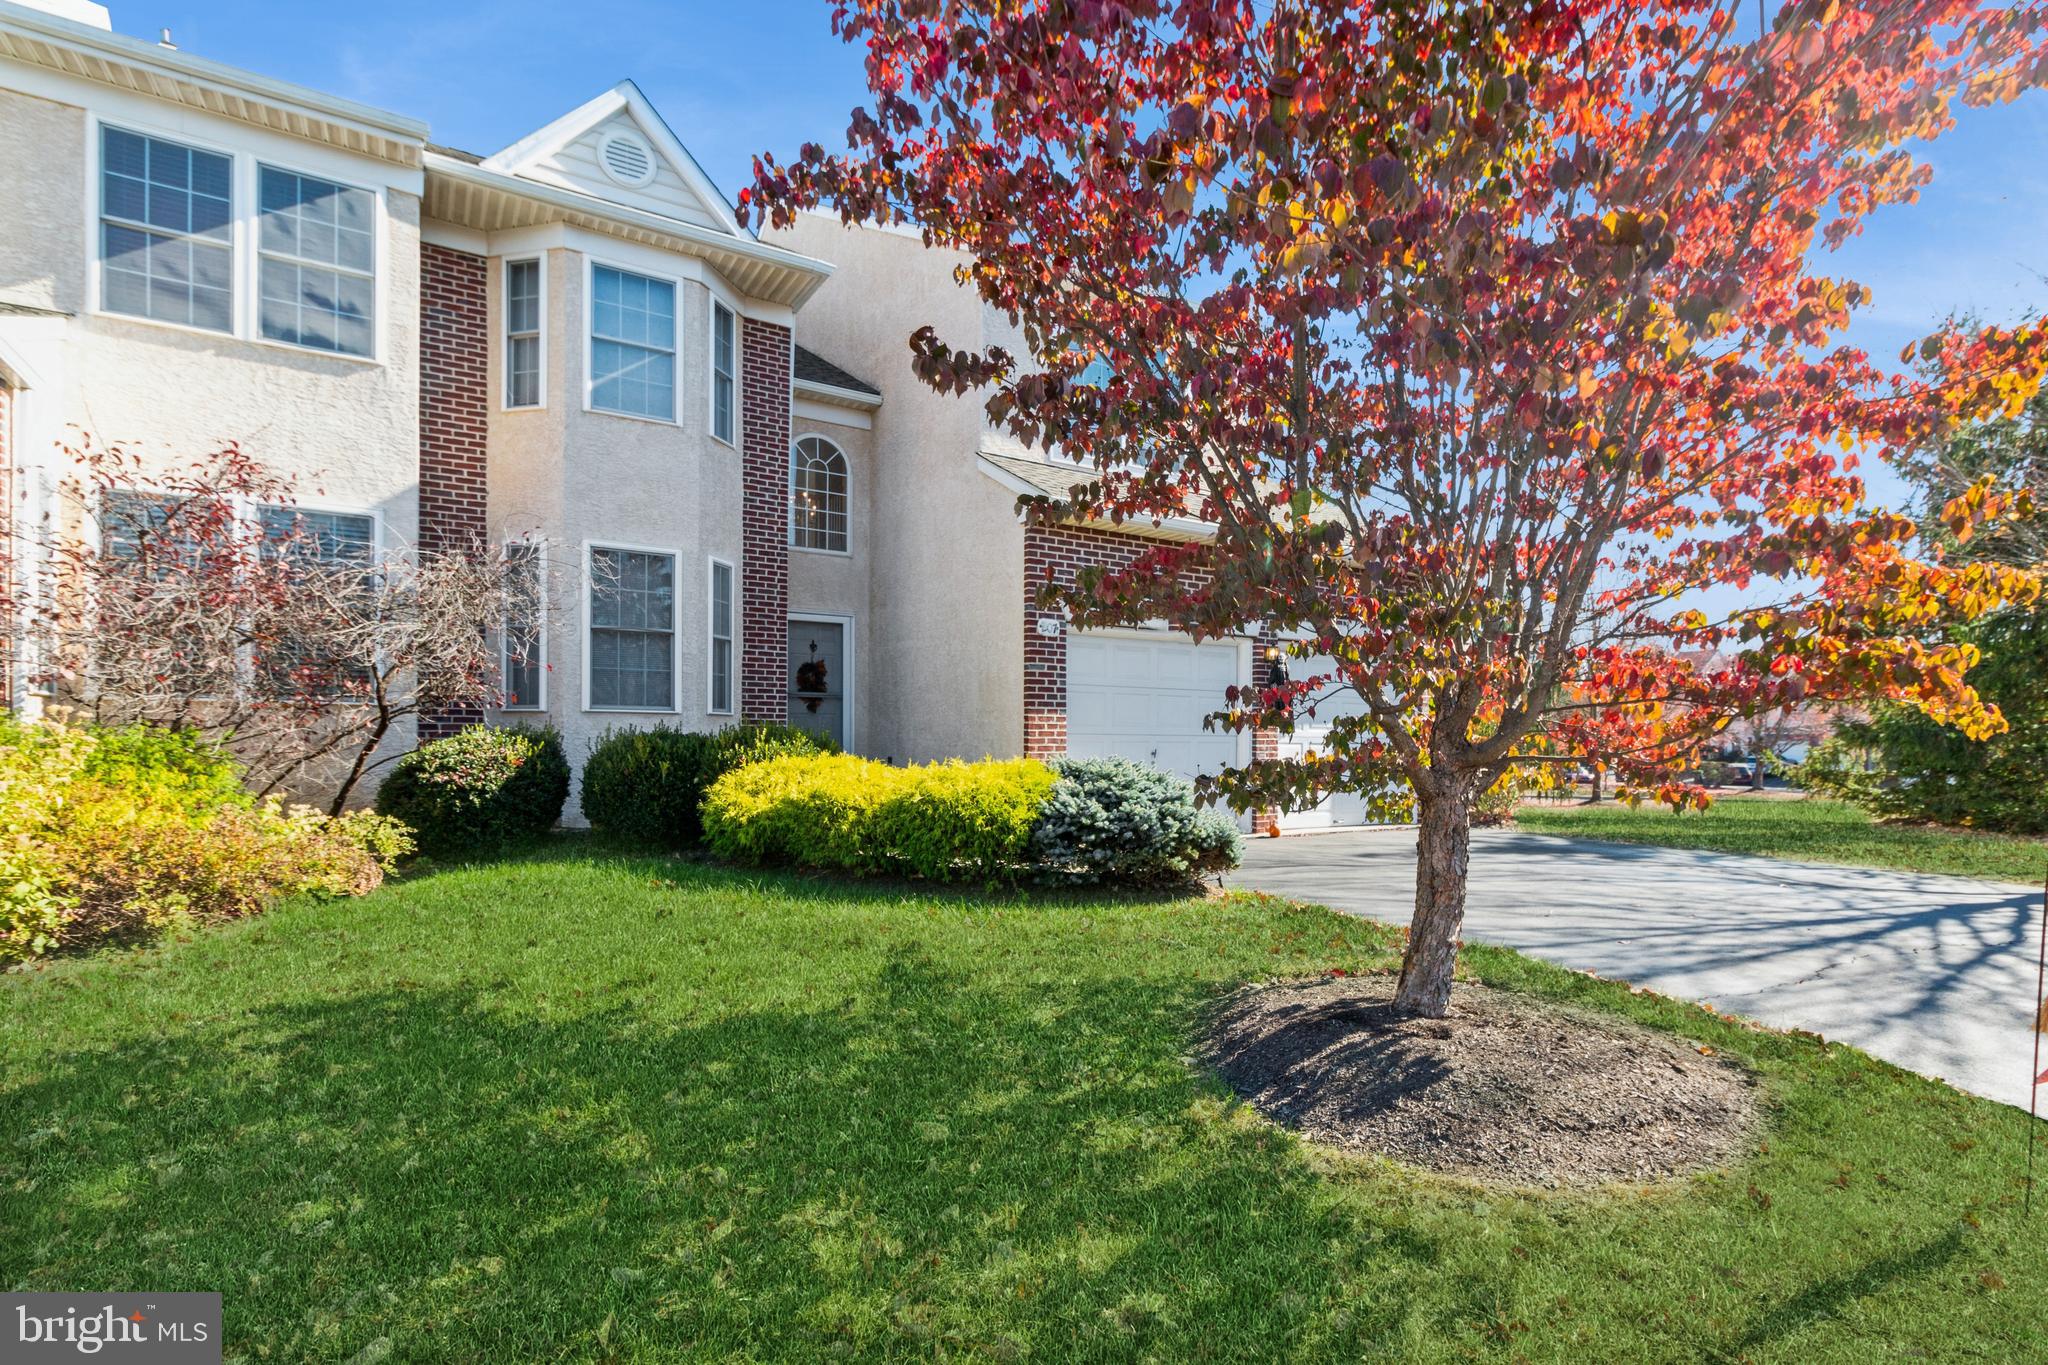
739, 317, 791, 722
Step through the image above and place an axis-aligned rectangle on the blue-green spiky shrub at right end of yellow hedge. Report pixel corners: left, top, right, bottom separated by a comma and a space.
1032, 759, 1243, 884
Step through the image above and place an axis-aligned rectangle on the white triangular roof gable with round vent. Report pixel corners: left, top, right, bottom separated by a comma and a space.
483, 80, 741, 237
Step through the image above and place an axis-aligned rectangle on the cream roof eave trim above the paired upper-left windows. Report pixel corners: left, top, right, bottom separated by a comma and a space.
0, 0, 428, 166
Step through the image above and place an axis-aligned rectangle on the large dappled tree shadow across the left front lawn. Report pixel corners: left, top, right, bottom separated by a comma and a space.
0, 945, 1436, 1361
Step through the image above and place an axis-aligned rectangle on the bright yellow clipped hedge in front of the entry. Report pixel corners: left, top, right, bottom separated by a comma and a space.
705, 755, 1053, 882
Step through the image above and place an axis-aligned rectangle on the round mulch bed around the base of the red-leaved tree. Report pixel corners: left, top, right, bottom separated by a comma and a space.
1204, 976, 1759, 1185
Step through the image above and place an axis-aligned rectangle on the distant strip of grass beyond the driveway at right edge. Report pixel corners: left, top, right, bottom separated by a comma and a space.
1516, 796, 2048, 886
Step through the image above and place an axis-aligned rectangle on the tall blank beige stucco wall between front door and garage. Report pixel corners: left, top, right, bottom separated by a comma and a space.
764, 215, 1024, 761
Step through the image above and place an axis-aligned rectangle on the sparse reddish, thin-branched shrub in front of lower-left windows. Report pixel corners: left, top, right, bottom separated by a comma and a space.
28, 436, 547, 814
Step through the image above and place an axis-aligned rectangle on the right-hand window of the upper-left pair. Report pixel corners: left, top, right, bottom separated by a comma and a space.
258, 166, 377, 356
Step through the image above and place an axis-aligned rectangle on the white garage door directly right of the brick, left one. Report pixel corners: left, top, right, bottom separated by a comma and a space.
1067, 634, 1241, 778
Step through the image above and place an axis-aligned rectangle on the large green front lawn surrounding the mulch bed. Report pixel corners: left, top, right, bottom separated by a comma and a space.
0, 845, 2048, 1365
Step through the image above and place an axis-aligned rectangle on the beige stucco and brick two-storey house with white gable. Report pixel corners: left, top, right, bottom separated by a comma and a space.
0, 0, 1350, 825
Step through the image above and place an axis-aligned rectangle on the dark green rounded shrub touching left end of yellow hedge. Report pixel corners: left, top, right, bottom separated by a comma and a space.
582, 724, 829, 847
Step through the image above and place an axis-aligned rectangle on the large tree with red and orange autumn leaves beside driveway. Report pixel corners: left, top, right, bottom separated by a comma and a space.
748, 0, 2048, 1015
